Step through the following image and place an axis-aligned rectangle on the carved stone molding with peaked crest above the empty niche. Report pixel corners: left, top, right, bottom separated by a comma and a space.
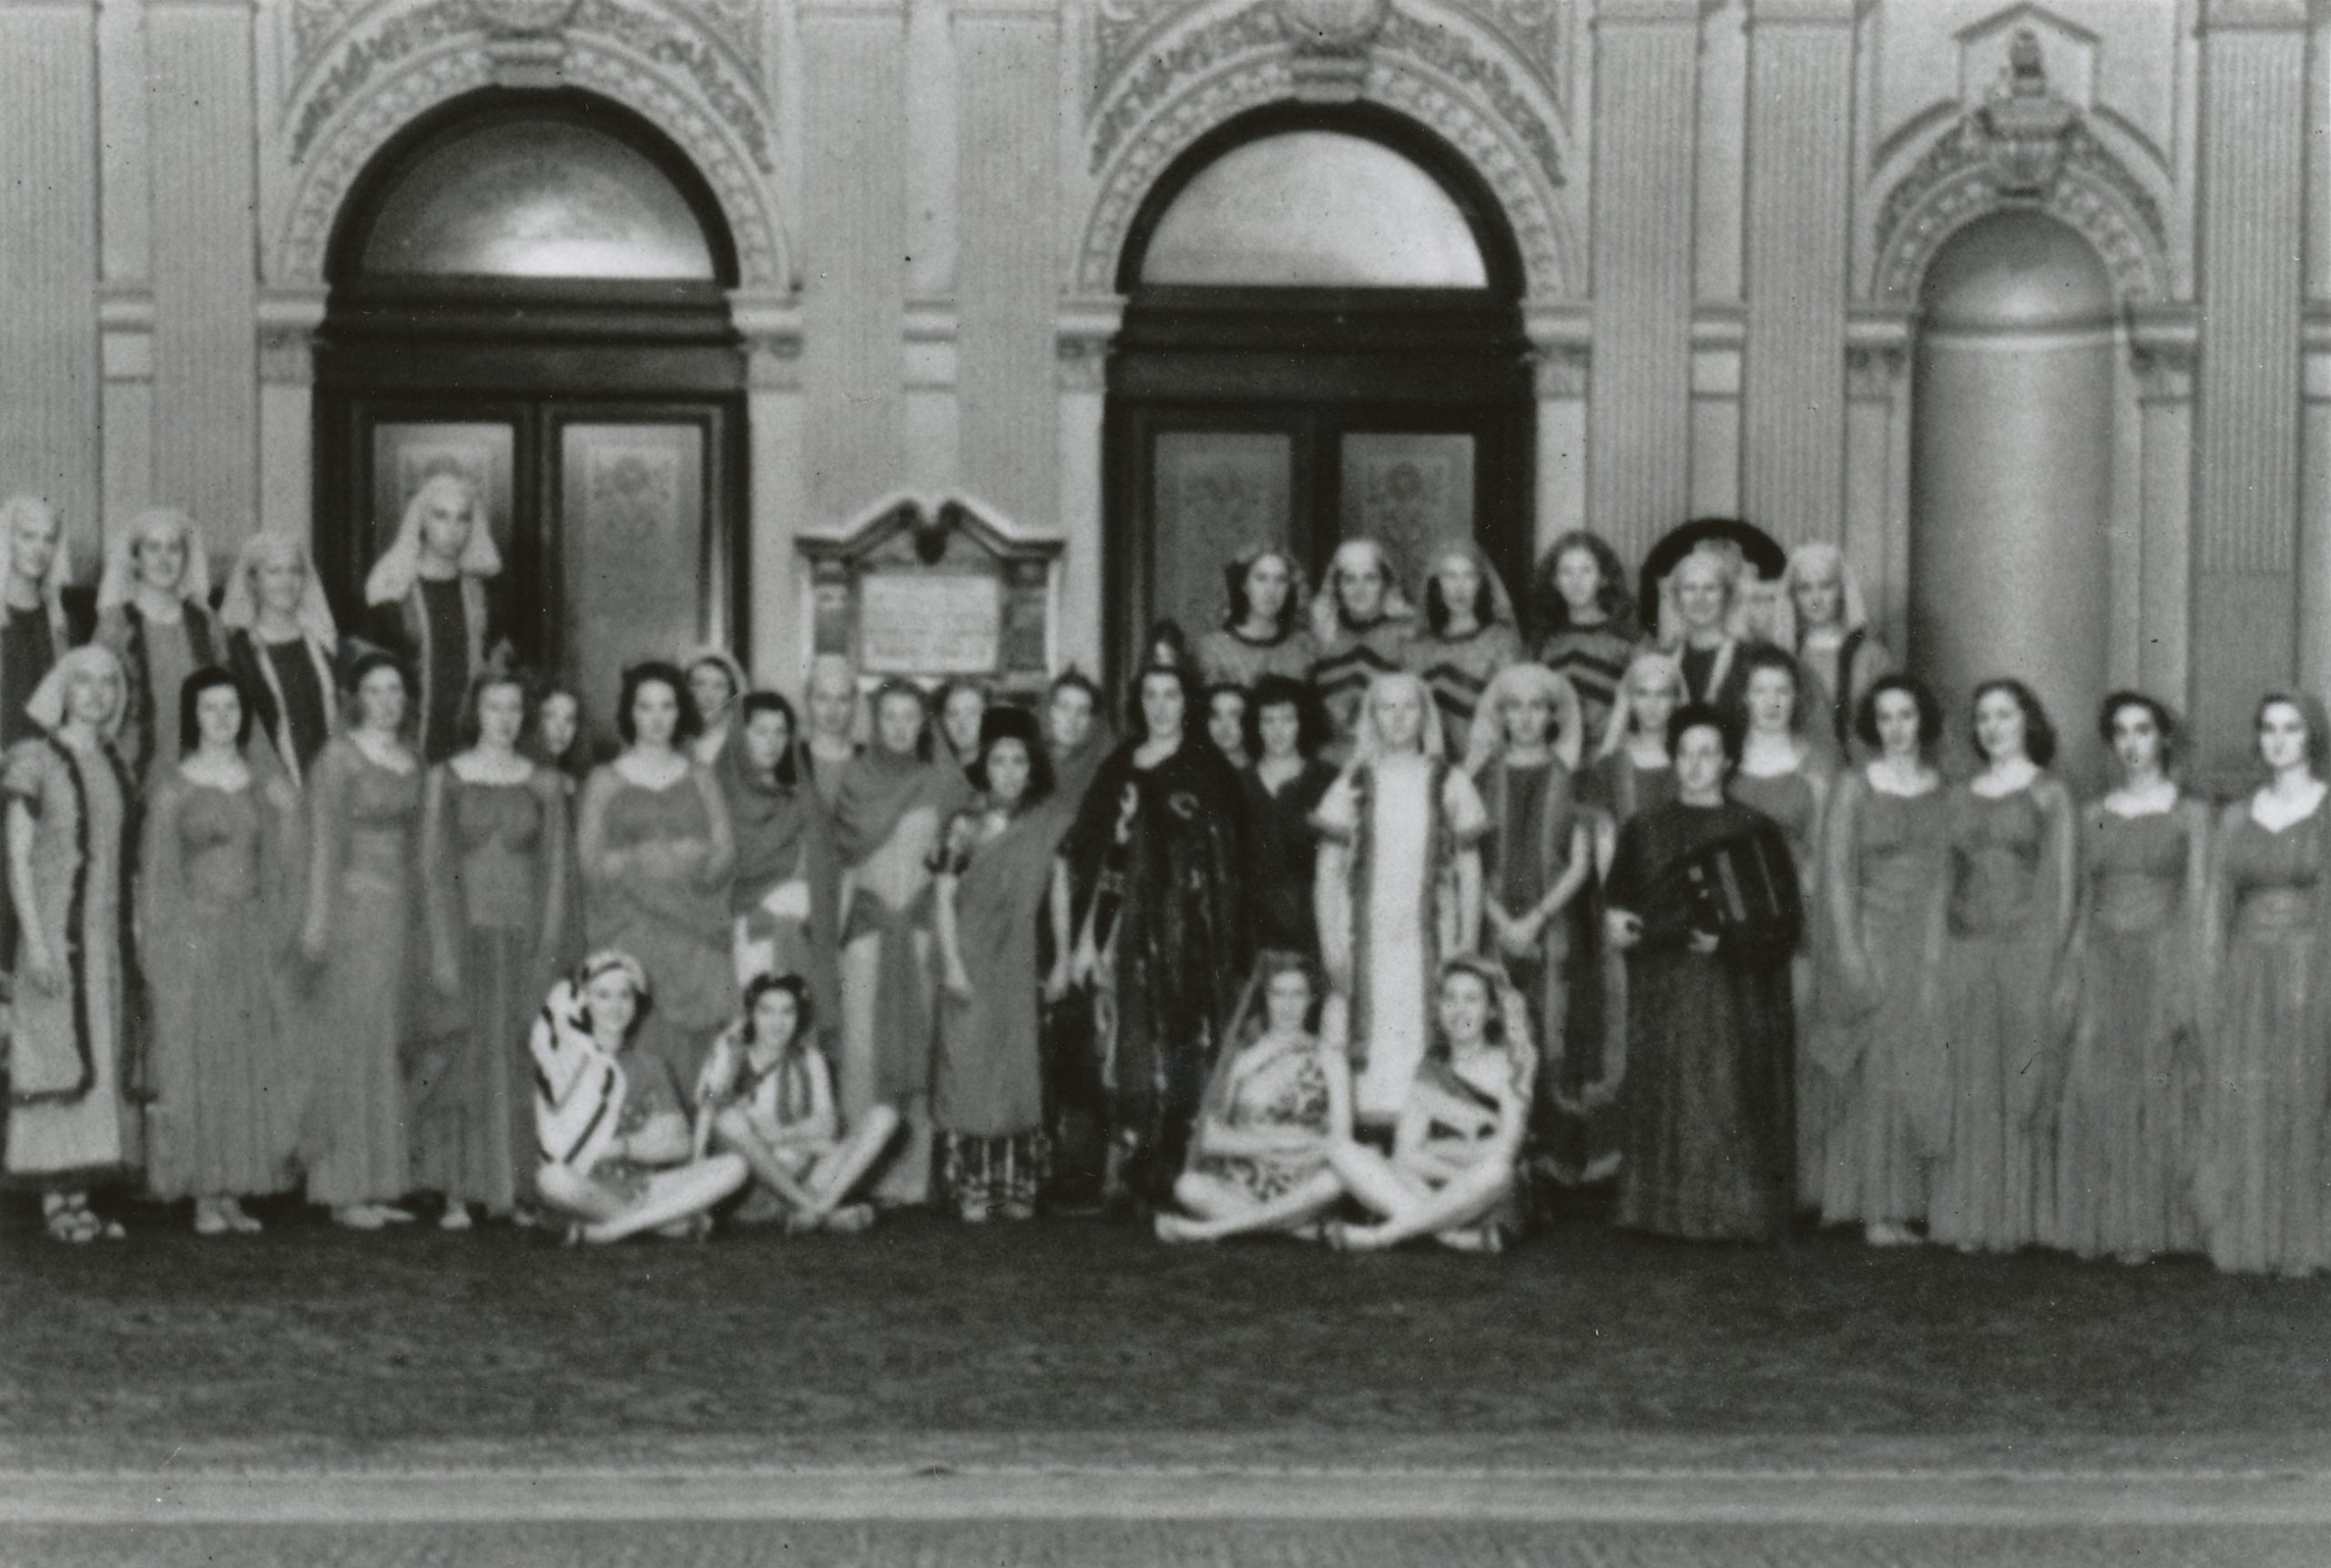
1872, 28, 2170, 303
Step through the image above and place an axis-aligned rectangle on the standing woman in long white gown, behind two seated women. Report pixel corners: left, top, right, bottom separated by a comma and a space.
1312, 673, 1487, 1127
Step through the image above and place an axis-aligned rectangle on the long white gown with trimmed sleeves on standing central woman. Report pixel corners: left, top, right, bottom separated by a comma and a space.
1312, 752, 1487, 1123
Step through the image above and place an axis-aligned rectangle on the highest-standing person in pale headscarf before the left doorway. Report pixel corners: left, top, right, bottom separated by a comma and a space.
363, 473, 511, 762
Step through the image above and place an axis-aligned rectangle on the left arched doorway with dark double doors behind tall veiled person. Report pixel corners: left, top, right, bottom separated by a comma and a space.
315, 91, 746, 734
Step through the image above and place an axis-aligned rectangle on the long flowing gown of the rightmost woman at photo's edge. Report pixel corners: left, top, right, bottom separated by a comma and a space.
2194, 801, 2331, 1275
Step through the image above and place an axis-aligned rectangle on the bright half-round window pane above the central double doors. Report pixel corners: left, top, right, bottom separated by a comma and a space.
1140, 130, 1490, 289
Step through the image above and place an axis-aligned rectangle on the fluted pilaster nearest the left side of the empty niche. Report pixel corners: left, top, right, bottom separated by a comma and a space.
1741, 0, 1853, 543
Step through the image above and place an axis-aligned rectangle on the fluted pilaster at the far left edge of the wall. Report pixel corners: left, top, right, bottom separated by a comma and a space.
0, 0, 98, 566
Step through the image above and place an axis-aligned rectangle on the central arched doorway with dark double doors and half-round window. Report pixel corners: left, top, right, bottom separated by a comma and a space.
1107, 105, 1533, 680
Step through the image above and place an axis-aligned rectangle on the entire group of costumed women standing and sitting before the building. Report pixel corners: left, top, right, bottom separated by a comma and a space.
0, 478, 2331, 1275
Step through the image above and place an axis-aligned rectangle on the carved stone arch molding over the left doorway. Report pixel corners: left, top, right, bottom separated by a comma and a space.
270, 0, 790, 289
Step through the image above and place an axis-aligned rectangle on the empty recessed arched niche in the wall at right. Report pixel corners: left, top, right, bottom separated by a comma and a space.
1909, 212, 2116, 769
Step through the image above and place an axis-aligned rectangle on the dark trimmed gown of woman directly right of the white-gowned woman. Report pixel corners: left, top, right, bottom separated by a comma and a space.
1475, 758, 1620, 1186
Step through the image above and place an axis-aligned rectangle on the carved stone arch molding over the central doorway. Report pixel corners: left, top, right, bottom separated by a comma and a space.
1074, 0, 1583, 296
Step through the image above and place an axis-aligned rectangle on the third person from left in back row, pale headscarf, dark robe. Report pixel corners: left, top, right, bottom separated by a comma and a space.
219, 531, 341, 785
